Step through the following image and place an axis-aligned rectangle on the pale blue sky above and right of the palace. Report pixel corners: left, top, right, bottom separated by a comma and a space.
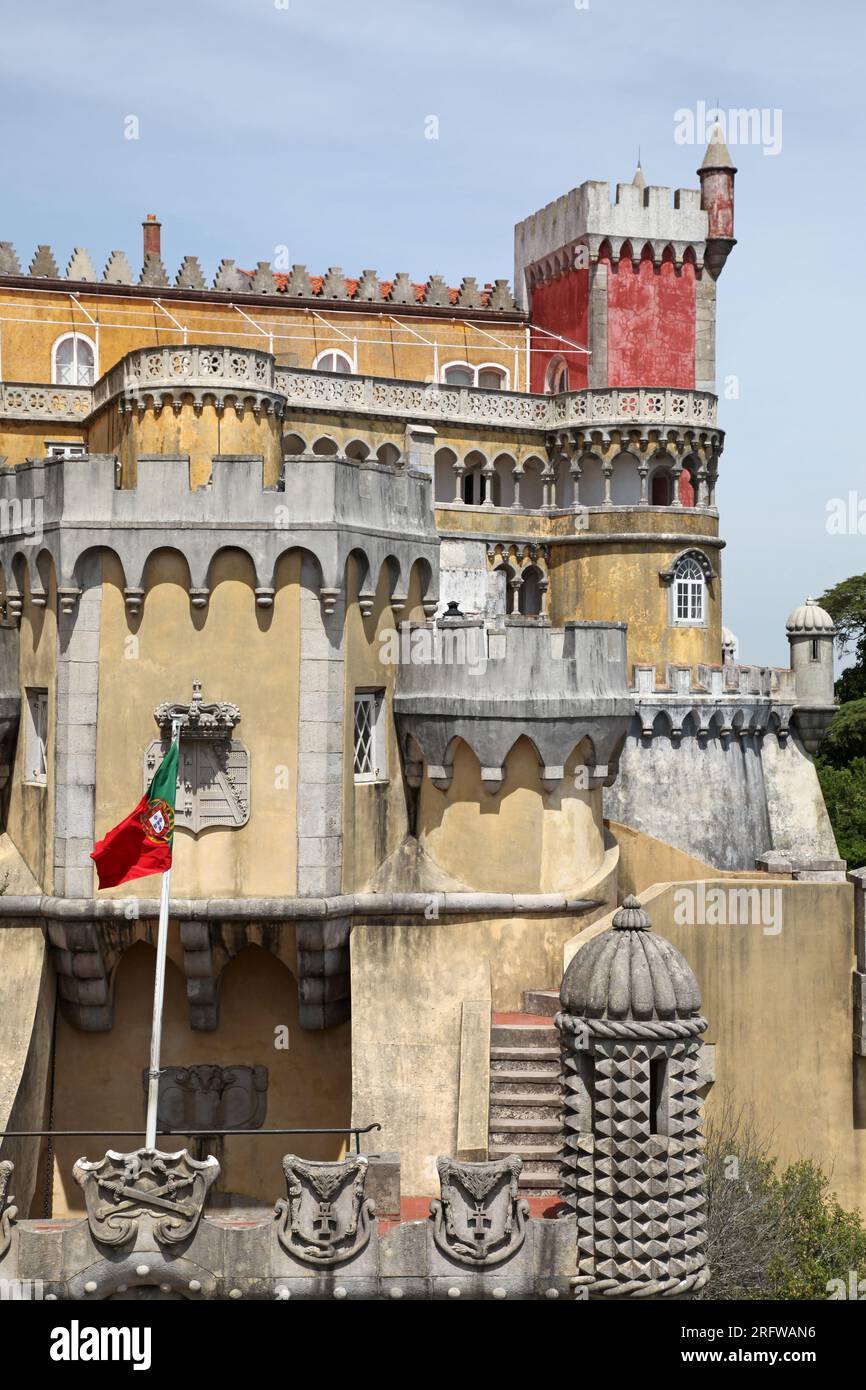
0, 0, 866, 664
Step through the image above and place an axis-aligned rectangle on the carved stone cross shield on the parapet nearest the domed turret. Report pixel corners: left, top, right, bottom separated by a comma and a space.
430, 1154, 530, 1268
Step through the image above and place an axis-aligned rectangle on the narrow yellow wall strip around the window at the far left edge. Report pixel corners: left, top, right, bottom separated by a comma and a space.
6, 566, 57, 892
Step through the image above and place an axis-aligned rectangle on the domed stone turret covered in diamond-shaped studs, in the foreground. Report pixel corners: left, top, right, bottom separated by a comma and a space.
556, 897, 709, 1297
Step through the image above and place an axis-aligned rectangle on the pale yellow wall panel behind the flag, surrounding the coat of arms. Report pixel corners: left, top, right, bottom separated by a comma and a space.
96, 552, 300, 898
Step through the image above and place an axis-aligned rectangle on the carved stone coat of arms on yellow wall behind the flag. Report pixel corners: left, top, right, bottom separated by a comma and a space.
145, 681, 250, 835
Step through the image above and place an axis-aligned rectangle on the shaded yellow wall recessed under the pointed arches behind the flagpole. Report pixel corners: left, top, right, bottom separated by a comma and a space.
54, 924, 352, 1216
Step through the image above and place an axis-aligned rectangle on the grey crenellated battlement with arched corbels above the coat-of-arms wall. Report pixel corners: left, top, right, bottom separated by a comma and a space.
0, 455, 439, 617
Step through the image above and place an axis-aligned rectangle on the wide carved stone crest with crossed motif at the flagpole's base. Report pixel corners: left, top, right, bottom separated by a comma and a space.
72, 1148, 220, 1245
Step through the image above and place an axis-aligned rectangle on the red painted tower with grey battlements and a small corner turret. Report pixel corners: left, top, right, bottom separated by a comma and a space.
514, 126, 737, 392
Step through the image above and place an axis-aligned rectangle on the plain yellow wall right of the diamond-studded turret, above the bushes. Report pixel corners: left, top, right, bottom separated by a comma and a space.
566, 874, 866, 1211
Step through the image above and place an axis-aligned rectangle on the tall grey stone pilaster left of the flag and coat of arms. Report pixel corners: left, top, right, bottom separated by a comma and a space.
54, 555, 102, 898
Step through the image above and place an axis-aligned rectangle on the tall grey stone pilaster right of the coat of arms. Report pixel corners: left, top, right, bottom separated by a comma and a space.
297, 556, 346, 897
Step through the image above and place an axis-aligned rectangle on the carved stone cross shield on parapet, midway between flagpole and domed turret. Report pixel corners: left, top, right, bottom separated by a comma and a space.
274, 1154, 375, 1265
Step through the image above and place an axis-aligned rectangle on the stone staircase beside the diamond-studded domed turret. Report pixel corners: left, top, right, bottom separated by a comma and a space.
488, 990, 563, 1197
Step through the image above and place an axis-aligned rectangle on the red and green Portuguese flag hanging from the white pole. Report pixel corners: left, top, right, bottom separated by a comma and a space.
90, 738, 178, 888
